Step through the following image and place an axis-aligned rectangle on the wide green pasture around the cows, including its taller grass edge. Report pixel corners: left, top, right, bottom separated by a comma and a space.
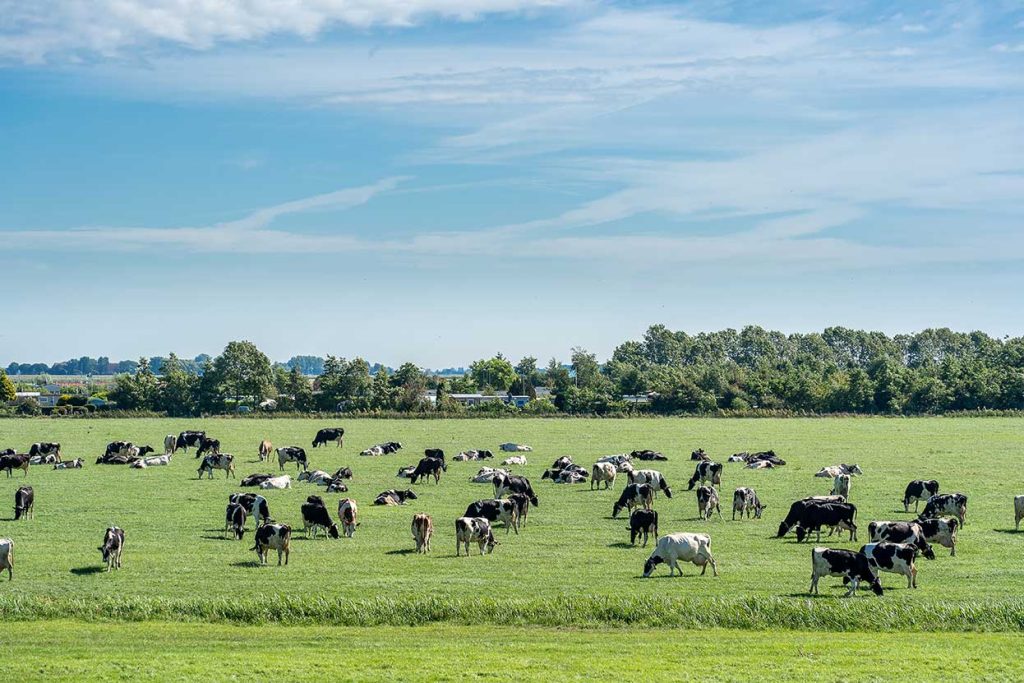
0, 418, 1024, 631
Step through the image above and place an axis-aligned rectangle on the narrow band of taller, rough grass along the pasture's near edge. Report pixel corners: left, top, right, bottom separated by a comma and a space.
0, 594, 1024, 632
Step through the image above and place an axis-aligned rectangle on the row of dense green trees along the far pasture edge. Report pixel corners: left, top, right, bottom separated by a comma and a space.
0, 325, 1024, 416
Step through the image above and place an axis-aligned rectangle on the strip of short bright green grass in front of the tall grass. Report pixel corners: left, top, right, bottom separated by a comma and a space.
0, 622, 1024, 681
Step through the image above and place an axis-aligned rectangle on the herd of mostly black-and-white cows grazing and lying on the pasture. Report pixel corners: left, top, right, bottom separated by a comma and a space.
0, 427, 1024, 596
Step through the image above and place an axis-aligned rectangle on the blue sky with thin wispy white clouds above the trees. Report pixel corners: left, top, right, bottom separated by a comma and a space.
0, 0, 1024, 367
